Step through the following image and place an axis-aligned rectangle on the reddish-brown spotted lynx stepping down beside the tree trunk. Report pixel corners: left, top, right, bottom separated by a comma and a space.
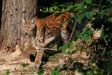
21, 12, 73, 67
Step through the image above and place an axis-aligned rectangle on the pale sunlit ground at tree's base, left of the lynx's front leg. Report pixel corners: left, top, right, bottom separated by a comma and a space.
0, 50, 37, 75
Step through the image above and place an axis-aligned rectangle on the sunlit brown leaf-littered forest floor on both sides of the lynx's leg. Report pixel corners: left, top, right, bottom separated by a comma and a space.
0, 36, 92, 75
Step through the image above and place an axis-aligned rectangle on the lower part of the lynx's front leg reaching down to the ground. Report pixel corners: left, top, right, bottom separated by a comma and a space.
34, 49, 44, 69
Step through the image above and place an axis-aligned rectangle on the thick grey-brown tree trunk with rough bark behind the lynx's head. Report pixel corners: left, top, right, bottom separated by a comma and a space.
0, 0, 37, 51
